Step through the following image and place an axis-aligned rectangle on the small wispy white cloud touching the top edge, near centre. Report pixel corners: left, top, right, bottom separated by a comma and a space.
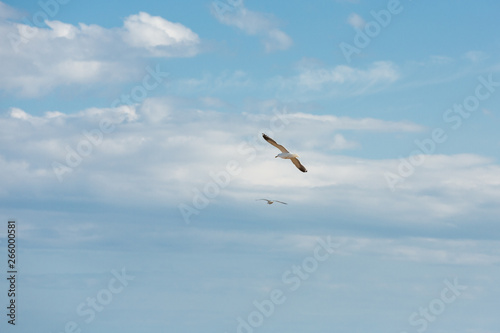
211, 1, 293, 52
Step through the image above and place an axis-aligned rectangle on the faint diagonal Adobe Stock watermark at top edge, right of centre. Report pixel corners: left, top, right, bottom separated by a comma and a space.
339, 0, 411, 63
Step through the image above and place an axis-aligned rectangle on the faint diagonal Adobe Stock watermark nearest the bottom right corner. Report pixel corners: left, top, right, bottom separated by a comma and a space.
401, 278, 467, 333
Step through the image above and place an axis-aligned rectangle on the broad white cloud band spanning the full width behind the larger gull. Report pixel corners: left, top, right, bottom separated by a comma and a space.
0, 98, 500, 230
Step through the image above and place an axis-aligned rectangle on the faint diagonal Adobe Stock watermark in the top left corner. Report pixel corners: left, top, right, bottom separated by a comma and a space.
7, 0, 70, 53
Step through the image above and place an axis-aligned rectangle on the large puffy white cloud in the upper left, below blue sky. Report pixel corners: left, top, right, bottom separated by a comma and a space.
0, 5, 201, 97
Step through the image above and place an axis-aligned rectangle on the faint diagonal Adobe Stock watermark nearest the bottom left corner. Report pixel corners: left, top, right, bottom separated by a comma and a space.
56, 267, 135, 333
